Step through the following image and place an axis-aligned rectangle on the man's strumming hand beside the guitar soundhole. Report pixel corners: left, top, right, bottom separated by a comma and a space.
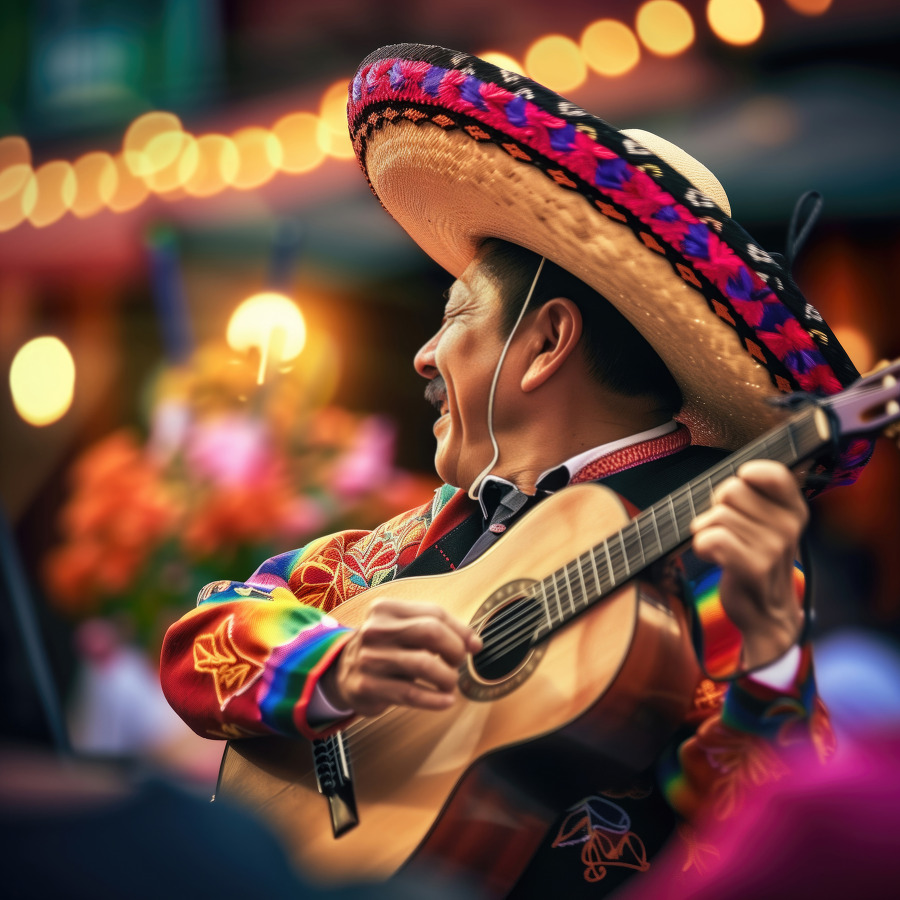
319, 600, 481, 716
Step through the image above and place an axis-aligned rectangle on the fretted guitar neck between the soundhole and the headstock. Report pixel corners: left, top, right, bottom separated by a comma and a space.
532, 407, 831, 644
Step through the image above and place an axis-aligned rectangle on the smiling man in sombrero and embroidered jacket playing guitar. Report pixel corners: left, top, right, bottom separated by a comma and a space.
162, 45, 865, 896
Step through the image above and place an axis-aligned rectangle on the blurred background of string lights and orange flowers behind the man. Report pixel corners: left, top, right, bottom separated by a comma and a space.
0, 0, 900, 786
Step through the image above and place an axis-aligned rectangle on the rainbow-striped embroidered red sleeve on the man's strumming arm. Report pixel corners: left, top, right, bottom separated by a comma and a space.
160, 503, 439, 739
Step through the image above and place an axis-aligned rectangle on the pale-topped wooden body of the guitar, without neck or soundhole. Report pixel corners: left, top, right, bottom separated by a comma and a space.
218, 485, 699, 896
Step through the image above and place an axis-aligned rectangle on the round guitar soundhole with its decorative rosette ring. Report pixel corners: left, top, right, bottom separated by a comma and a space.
459, 579, 545, 700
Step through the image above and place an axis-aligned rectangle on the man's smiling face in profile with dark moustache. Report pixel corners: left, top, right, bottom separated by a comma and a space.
415, 258, 505, 490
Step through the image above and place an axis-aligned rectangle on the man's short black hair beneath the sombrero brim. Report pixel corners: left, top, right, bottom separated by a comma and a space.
480, 238, 682, 415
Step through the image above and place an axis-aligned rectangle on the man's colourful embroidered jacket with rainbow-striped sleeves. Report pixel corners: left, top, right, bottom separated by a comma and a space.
161, 464, 832, 896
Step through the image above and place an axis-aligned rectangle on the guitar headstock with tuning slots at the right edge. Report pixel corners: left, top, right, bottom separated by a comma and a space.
820, 359, 900, 447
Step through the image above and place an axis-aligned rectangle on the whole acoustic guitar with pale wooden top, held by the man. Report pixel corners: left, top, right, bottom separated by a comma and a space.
217, 361, 900, 896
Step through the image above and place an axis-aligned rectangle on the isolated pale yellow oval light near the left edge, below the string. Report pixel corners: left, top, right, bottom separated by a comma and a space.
9, 335, 75, 427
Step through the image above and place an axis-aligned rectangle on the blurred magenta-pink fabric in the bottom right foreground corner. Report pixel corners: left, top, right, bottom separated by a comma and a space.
616, 724, 900, 900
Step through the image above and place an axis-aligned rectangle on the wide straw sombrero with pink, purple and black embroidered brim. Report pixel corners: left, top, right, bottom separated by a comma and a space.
348, 44, 871, 483
